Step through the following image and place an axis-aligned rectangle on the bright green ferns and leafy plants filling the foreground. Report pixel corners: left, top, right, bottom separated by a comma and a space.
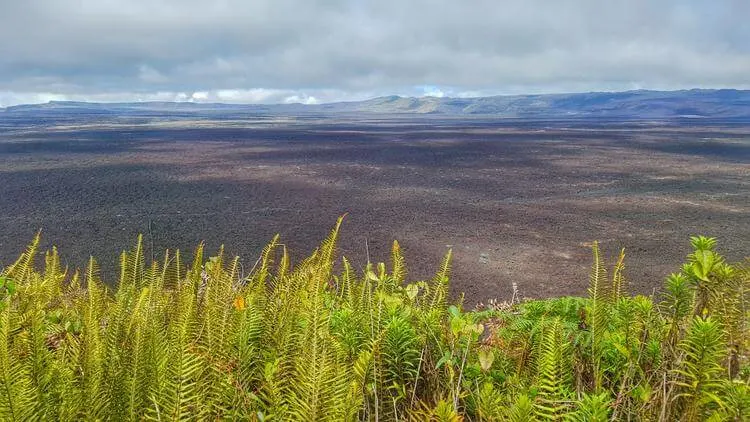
0, 220, 750, 421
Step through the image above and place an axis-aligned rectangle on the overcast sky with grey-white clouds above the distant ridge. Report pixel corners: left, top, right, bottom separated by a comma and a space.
0, 0, 750, 107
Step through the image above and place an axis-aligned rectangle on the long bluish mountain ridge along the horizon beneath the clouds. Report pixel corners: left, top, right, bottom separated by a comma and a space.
0, 89, 750, 119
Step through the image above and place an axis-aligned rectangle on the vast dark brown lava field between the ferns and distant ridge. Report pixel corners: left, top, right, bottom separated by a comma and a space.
0, 116, 750, 304
